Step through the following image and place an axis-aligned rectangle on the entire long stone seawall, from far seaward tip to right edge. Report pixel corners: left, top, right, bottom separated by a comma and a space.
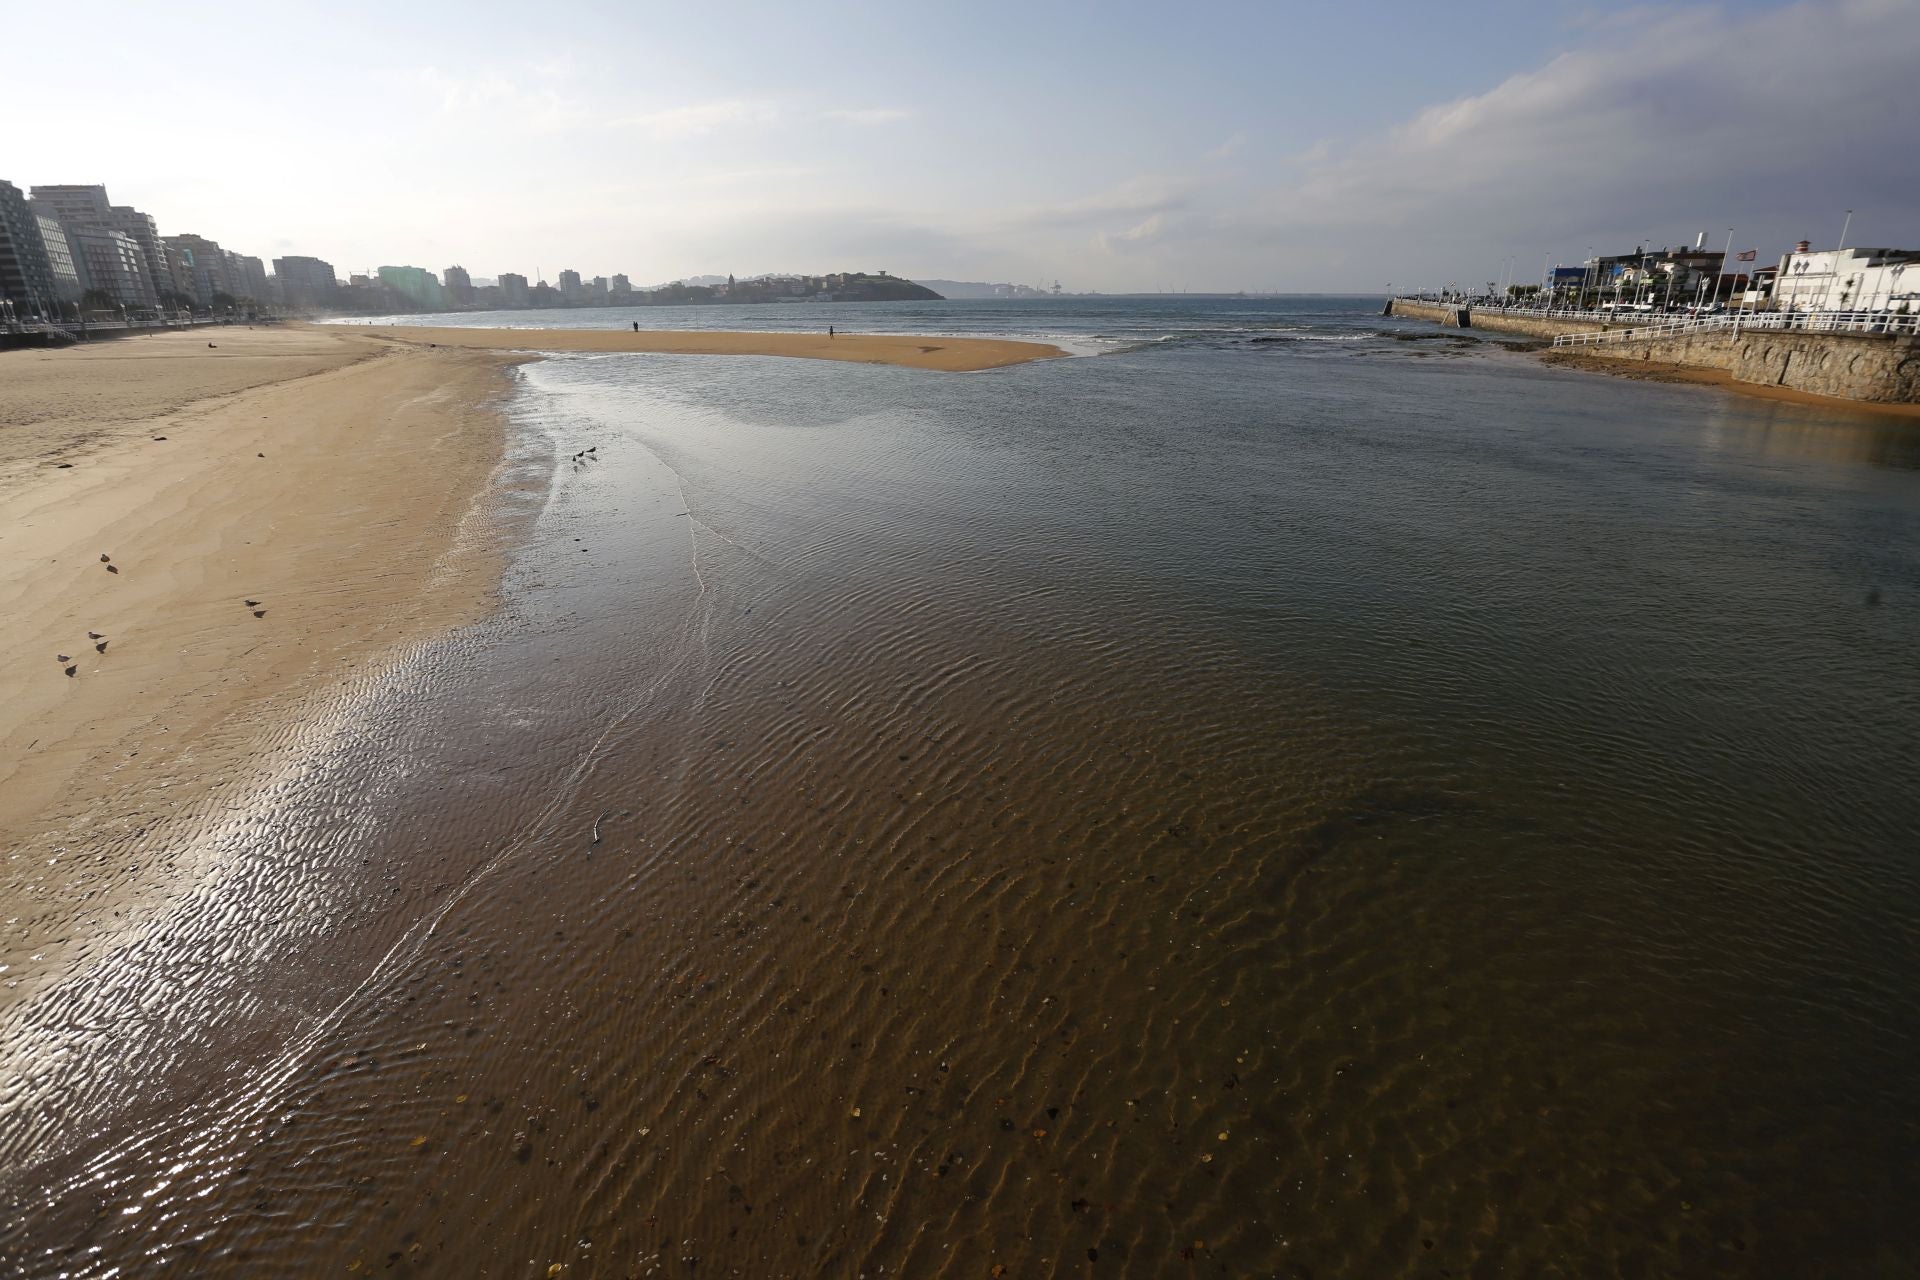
1386, 297, 1920, 405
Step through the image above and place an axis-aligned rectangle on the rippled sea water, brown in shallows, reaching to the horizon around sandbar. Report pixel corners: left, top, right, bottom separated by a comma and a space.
11, 299, 1920, 1276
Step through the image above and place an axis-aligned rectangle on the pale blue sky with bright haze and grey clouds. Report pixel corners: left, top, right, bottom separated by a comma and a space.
0, 0, 1920, 292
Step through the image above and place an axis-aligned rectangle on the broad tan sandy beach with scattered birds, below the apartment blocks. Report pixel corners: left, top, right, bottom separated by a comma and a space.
0, 328, 515, 1009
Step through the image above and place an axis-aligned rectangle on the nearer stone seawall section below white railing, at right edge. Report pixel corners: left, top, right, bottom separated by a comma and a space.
1578, 328, 1920, 405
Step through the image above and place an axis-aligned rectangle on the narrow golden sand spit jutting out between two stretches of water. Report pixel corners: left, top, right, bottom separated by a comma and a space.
353, 326, 1066, 372
